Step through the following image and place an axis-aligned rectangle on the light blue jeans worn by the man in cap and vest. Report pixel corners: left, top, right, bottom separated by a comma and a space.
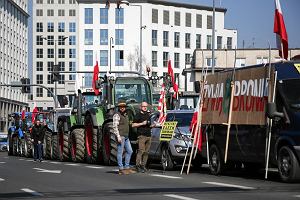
117, 136, 133, 170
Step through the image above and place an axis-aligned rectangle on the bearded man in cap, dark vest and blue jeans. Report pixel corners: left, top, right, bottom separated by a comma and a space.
113, 100, 135, 174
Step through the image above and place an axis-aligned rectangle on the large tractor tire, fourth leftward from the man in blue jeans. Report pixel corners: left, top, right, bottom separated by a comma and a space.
58, 121, 70, 161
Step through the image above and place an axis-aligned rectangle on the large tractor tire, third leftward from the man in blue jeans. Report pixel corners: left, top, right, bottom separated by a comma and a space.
70, 128, 85, 162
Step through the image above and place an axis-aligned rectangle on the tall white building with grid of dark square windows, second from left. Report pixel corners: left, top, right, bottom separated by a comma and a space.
29, 0, 80, 110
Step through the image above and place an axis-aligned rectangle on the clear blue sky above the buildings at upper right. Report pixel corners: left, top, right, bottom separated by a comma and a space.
172, 0, 300, 48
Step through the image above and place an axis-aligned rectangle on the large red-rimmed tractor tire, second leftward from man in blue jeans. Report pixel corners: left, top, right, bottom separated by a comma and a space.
84, 115, 98, 164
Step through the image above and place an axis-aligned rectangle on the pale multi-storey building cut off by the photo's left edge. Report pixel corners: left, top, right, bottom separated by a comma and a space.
0, 0, 29, 132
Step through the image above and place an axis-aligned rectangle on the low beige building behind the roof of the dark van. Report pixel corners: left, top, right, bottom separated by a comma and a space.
183, 48, 300, 91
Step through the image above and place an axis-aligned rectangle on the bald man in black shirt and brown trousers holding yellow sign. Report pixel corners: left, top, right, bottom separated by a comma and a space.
132, 102, 151, 173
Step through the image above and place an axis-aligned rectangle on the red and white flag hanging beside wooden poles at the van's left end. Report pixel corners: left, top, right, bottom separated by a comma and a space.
190, 98, 202, 151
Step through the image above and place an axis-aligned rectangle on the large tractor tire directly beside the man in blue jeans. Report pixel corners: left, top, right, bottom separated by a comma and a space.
102, 122, 118, 165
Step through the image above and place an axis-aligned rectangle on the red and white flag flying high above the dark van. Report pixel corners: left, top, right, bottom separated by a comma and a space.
274, 0, 289, 59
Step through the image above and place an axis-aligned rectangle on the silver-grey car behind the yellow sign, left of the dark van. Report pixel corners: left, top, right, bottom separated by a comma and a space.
149, 110, 194, 170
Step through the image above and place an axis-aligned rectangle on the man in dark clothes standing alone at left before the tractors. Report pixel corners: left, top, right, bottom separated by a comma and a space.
31, 119, 44, 162
